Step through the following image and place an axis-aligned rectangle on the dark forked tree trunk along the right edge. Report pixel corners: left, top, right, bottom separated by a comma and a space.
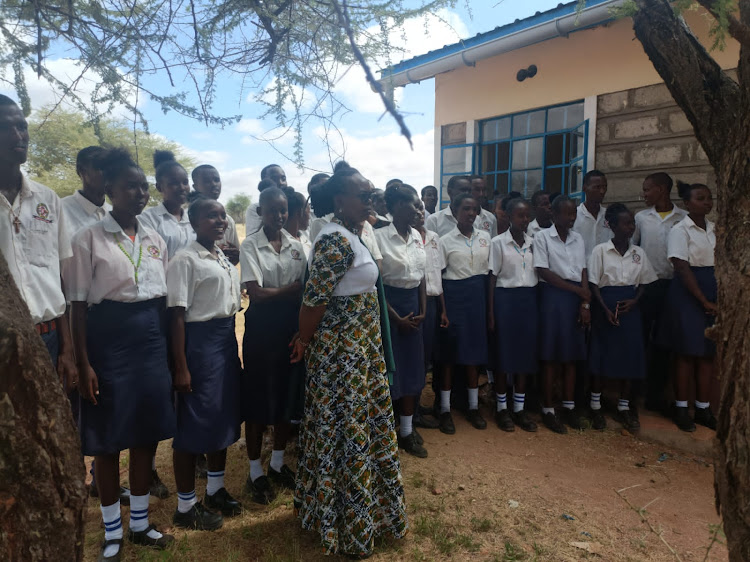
633, 0, 750, 562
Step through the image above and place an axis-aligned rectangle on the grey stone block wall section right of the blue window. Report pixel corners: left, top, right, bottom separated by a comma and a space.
589, 84, 714, 209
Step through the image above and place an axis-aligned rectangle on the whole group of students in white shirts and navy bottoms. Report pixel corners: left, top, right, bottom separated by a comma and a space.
0, 87, 716, 560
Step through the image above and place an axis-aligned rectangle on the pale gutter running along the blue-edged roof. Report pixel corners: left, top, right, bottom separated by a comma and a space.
379, 0, 624, 89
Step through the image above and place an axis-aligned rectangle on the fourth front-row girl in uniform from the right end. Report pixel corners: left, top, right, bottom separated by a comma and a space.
487, 199, 539, 432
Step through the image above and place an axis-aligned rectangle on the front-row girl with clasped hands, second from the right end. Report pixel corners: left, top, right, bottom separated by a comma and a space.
588, 203, 656, 430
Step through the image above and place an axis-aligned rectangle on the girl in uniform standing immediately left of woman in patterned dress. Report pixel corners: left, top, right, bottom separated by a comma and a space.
240, 187, 306, 504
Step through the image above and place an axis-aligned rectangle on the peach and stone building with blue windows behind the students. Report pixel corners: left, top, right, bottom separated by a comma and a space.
381, 0, 739, 206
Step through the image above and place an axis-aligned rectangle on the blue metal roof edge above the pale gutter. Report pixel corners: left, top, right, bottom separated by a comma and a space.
380, 0, 608, 80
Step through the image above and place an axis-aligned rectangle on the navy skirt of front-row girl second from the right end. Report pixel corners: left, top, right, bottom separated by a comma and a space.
589, 286, 646, 379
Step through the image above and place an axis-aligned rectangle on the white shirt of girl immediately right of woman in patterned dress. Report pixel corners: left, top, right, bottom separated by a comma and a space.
375, 224, 427, 289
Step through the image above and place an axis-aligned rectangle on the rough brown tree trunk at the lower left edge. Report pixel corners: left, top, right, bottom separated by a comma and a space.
0, 254, 86, 561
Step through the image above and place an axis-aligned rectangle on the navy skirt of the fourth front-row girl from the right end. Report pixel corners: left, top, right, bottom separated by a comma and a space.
494, 287, 539, 376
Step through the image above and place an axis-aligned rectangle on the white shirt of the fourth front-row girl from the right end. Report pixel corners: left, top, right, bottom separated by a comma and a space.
490, 230, 538, 289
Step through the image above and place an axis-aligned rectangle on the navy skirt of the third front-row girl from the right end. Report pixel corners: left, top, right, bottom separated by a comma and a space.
539, 283, 586, 363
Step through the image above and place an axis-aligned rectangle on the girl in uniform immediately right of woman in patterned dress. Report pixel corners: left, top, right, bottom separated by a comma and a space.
375, 183, 427, 458
